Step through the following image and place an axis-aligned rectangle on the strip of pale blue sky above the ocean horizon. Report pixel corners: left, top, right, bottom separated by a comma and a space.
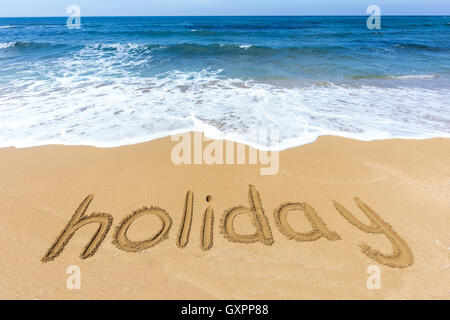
0, 0, 450, 17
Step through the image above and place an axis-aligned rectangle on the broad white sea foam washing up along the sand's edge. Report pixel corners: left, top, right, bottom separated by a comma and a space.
0, 44, 450, 149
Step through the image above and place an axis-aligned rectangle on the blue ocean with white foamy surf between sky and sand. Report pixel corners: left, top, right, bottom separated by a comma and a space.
0, 16, 450, 149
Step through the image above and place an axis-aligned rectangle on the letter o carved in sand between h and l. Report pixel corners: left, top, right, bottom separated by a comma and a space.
113, 207, 172, 252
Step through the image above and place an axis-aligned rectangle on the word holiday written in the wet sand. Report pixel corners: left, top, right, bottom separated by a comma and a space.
42, 185, 414, 268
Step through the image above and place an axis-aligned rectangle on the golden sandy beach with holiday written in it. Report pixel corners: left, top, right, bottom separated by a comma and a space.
0, 136, 450, 299
